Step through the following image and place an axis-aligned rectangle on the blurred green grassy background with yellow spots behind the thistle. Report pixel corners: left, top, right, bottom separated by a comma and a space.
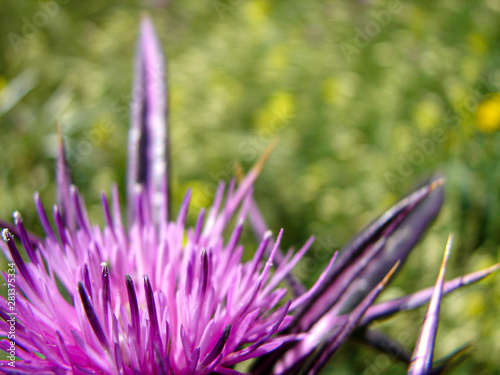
0, 0, 500, 375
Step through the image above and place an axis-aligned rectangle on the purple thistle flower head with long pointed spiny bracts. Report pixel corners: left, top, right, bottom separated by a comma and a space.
0, 18, 498, 375
